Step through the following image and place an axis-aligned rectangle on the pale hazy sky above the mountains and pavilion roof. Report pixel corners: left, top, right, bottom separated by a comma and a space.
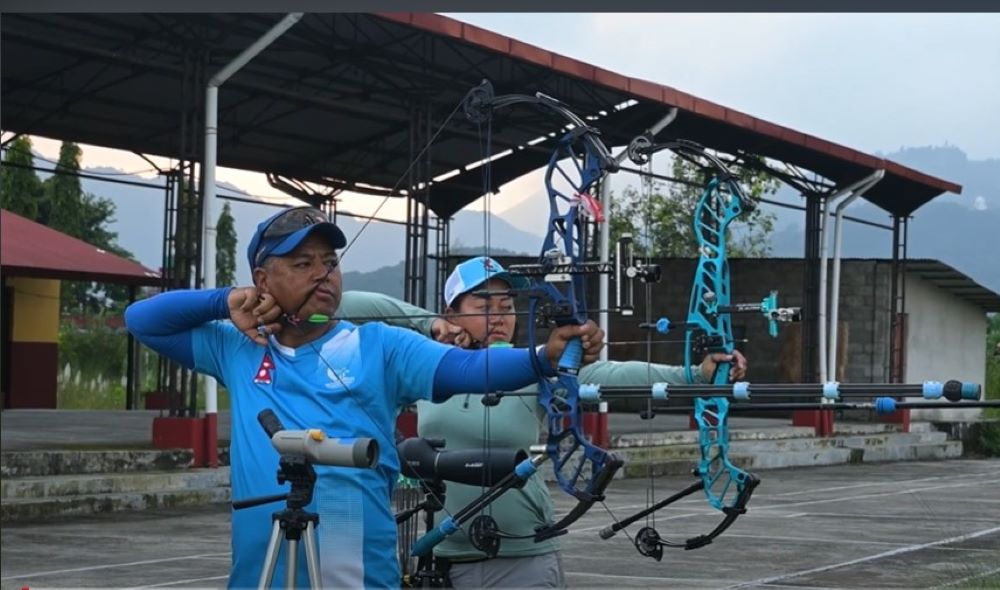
17, 13, 1000, 224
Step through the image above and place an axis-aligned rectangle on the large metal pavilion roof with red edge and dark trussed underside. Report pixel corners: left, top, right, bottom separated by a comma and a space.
0, 13, 961, 217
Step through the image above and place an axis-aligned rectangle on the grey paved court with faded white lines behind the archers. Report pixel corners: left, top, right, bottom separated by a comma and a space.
0, 460, 1000, 590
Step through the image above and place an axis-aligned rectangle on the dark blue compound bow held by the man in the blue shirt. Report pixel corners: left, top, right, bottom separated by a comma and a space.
415, 82, 623, 554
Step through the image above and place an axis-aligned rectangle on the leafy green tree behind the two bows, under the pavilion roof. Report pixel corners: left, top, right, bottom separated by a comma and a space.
610, 157, 779, 257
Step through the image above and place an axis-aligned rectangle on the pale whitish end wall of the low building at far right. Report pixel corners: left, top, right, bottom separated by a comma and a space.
904, 276, 986, 420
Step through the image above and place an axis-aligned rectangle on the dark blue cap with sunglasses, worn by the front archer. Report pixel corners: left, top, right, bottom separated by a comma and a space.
247, 207, 347, 270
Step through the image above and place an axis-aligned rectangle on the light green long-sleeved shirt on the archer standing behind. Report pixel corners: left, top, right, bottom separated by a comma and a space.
339, 291, 701, 560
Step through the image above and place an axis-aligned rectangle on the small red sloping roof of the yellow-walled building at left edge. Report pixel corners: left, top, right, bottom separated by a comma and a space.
0, 209, 160, 285
